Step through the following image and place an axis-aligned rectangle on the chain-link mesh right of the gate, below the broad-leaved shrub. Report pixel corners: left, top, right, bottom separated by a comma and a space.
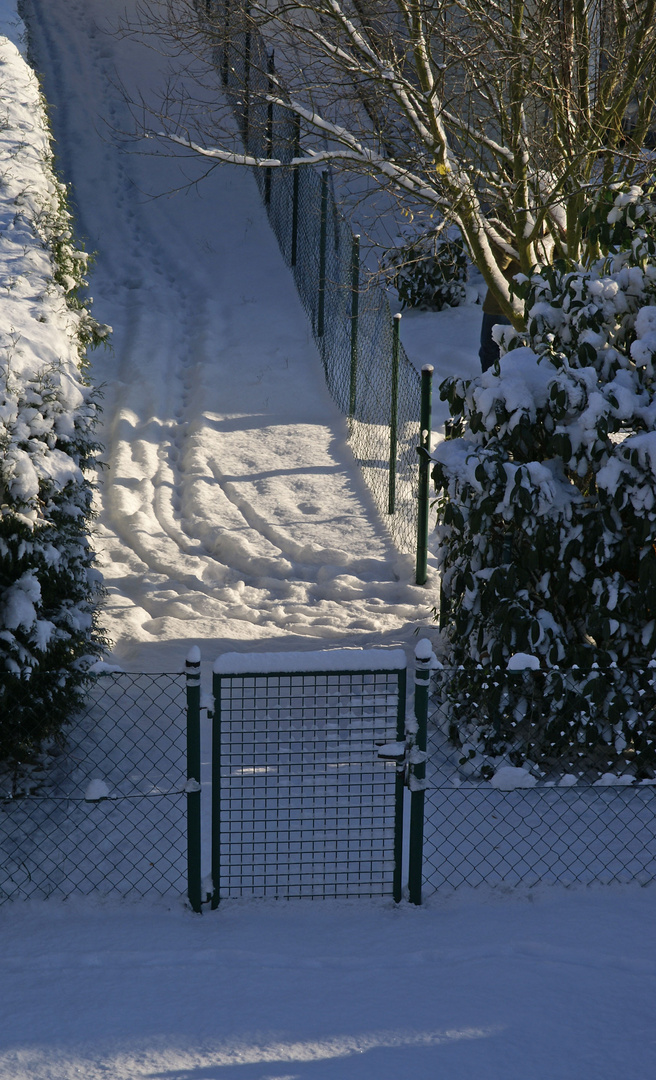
424, 671, 656, 895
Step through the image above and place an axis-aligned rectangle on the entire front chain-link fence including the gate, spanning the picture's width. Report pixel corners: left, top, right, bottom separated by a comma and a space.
5, 650, 656, 910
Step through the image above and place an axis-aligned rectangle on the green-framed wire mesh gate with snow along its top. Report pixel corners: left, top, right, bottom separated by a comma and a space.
212, 649, 405, 907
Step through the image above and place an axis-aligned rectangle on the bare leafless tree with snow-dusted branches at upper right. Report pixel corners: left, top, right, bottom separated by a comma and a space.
121, 0, 656, 326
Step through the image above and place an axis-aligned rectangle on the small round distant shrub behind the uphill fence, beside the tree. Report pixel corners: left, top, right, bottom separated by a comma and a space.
384, 232, 467, 311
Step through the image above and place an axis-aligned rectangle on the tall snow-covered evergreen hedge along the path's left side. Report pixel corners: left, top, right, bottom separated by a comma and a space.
0, 38, 108, 758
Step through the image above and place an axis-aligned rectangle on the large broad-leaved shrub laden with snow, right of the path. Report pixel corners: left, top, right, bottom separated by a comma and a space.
434, 187, 656, 775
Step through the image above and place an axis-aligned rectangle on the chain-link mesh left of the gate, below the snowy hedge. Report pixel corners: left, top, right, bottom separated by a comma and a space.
0, 673, 186, 902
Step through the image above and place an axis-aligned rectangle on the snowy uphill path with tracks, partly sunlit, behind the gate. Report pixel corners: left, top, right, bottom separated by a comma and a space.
25, 0, 433, 670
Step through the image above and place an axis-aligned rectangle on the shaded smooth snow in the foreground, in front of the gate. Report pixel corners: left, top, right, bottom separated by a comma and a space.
0, 888, 656, 1080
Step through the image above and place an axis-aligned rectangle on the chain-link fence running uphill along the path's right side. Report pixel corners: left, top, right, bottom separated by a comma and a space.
201, 0, 420, 553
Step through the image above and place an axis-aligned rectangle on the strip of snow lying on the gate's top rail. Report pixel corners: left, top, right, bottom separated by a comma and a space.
214, 648, 407, 675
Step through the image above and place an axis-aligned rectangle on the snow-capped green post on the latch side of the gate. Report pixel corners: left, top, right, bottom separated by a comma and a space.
407, 638, 433, 904
